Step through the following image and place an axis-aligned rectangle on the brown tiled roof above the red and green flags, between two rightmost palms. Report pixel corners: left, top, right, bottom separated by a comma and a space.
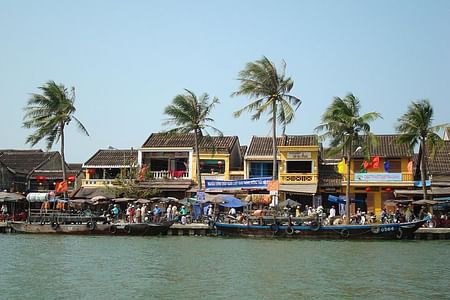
355, 134, 414, 158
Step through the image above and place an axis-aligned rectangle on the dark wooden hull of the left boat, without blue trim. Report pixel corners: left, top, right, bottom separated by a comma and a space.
11, 222, 173, 236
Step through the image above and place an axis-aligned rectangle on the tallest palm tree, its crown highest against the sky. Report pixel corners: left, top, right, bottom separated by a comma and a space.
232, 56, 302, 180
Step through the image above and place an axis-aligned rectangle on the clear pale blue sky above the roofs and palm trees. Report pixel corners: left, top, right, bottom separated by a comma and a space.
0, 0, 450, 162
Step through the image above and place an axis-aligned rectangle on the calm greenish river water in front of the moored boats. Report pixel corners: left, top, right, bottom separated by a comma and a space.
0, 234, 450, 299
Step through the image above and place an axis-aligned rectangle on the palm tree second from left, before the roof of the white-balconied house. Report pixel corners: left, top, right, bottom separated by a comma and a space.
164, 89, 222, 190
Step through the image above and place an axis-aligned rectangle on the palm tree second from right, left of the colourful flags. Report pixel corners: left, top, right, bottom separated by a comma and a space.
316, 94, 381, 224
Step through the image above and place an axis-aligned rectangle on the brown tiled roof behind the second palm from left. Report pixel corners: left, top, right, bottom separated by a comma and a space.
142, 133, 238, 153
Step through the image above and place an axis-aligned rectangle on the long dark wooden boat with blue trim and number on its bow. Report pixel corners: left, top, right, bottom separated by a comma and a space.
214, 216, 427, 239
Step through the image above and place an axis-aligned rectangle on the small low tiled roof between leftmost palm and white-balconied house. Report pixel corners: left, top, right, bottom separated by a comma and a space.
83, 149, 138, 168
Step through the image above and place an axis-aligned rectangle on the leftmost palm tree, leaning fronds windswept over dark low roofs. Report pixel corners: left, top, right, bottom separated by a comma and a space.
23, 81, 89, 191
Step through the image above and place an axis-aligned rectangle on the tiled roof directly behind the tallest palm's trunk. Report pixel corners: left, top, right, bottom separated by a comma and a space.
247, 135, 319, 156
